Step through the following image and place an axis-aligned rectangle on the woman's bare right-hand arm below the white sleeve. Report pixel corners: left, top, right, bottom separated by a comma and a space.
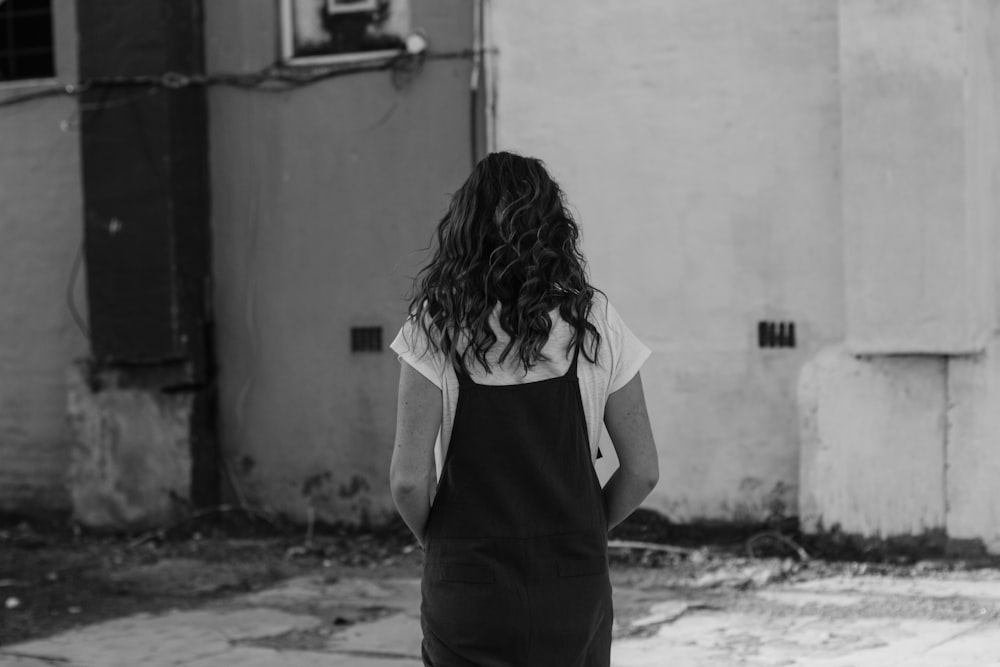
604, 373, 660, 530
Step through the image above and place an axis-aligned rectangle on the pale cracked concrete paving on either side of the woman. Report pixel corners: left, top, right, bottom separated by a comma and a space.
0, 560, 1000, 667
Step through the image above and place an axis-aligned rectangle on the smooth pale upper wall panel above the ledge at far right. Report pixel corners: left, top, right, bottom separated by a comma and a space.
840, 0, 998, 354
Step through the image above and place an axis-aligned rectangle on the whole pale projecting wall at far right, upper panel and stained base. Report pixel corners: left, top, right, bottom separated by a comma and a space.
801, 0, 1000, 553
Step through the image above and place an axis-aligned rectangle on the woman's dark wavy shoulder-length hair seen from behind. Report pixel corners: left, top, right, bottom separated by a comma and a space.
409, 152, 601, 373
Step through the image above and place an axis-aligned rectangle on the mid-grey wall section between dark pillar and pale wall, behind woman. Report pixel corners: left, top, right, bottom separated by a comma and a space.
206, 0, 473, 521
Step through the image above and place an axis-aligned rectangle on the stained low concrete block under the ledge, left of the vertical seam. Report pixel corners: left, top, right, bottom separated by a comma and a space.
798, 346, 947, 538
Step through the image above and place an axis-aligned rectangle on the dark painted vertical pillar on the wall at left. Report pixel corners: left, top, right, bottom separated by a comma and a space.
77, 0, 218, 504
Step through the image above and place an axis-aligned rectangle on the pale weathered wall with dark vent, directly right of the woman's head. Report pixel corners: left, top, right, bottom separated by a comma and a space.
491, 0, 844, 520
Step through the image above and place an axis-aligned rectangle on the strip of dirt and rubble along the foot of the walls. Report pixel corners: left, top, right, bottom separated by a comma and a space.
0, 508, 1000, 645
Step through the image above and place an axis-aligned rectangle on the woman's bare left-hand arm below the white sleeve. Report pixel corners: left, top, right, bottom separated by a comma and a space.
389, 361, 441, 546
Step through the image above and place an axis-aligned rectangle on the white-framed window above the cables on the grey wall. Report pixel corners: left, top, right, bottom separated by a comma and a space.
282, 0, 410, 65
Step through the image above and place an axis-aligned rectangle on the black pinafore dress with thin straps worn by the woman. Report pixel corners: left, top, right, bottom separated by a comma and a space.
421, 346, 613, 667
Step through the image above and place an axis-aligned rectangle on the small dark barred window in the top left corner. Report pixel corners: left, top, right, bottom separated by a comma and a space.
0, 0, 56, 82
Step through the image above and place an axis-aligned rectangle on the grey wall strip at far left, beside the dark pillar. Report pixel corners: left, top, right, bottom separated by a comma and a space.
0, 2, 87, 513
